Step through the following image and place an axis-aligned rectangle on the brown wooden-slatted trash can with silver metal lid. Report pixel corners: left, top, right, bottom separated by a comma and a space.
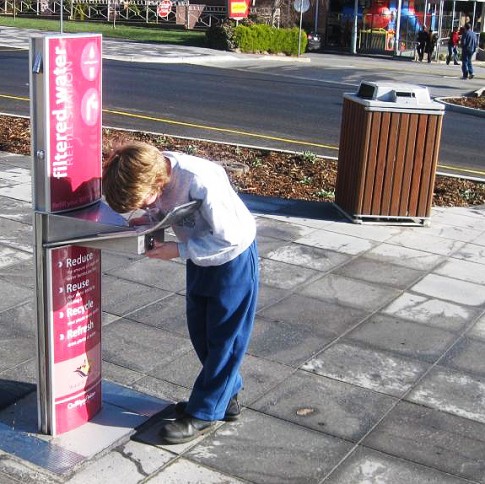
335, 81, 445, 225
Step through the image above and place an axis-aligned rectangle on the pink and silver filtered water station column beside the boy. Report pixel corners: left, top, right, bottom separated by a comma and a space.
29, 34, 102, 435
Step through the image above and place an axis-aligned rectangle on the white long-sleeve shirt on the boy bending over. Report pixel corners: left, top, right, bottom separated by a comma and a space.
155, 151, 256, 266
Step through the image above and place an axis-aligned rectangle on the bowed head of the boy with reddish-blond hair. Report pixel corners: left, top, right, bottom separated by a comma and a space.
103, 142, 170, 213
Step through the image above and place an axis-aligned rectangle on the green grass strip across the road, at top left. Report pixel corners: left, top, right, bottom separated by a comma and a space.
0, 17, 205, 47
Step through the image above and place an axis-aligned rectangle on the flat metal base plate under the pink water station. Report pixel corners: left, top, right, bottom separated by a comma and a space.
0, 381, 171, 475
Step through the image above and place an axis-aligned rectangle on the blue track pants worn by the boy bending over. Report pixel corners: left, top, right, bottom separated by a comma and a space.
186, 241, 259, 420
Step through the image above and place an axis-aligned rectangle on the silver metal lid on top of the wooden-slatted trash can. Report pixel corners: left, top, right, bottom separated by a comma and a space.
344, 80, 444, 114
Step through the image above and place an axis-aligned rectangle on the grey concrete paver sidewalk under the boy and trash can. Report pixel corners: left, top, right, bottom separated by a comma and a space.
0, 149, 485, 484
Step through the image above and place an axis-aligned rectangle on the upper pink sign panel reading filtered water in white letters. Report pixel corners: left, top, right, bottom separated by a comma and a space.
45, 35, 102, 212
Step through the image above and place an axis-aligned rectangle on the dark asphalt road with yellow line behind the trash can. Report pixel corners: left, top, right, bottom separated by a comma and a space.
0, 51, 485, 178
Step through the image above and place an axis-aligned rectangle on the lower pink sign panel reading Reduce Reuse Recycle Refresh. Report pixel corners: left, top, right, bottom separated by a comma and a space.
49, 245, 101, 435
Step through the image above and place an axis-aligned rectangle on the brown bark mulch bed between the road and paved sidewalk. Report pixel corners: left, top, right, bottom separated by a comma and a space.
0, 116, 485, 207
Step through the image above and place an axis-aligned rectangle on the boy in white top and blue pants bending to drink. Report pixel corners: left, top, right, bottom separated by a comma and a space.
103, 142, 259, 444
